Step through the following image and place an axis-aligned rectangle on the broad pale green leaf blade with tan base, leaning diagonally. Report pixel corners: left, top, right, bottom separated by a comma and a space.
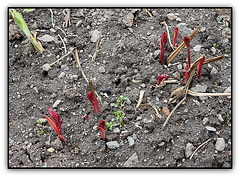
9, 9, 44, 53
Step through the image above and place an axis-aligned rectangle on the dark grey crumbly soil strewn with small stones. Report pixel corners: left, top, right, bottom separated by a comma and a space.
8, 8, 232, 168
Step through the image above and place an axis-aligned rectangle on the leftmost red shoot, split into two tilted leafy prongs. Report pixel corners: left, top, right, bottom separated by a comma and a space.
44, 106, 65, 143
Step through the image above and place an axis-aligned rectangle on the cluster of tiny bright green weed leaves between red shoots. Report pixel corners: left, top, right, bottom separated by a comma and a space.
106, 96, 127, 130
